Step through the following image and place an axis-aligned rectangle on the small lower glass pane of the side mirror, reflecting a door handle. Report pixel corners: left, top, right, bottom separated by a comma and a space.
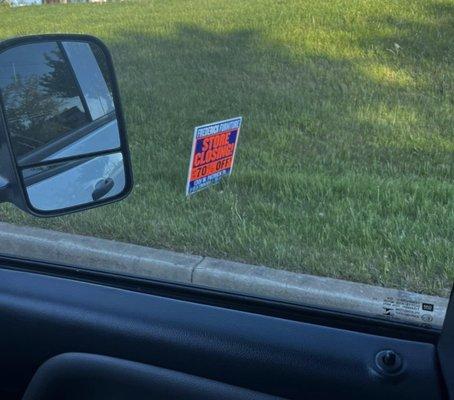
22, 152, 126, 212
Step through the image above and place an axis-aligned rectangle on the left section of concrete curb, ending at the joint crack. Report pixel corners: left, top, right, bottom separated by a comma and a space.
0, 222, 203, 283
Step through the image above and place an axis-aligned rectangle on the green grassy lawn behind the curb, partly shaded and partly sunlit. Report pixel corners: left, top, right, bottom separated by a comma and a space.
0, 0, 454, 294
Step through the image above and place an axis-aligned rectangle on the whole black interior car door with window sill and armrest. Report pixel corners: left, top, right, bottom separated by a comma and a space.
0, 252, 452, 399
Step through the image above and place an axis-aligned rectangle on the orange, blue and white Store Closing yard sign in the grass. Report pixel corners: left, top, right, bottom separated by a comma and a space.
186, 117, 242, 196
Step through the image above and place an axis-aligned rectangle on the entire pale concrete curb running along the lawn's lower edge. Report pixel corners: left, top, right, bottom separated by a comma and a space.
0, 222, 448, 328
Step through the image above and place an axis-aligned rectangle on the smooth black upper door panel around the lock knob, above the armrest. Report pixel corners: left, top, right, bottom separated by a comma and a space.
0, 269, 442, 400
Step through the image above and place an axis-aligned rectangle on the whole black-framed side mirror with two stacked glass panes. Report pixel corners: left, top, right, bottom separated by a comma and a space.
0, 35, 133, 216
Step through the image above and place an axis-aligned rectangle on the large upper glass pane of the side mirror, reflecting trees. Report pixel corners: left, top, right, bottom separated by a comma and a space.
0, 41, 120, 166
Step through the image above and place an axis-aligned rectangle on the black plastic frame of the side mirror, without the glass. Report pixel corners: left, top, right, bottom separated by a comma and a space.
0, 34, 134, 217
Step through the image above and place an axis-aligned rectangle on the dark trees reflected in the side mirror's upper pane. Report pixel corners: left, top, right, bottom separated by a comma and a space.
2, 48, 87, 156
